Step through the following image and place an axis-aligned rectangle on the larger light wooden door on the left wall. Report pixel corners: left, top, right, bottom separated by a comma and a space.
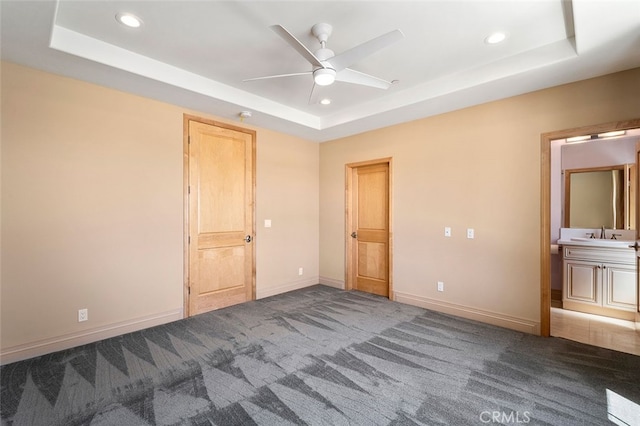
185, 117, 255, 316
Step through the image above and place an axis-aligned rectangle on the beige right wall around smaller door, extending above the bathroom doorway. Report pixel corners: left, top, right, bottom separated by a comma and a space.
320, 69, 640, 332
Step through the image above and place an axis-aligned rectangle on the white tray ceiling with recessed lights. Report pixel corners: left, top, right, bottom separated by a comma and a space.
0, 0, 640, 142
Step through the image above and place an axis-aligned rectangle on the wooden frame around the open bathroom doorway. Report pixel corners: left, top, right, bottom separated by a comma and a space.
540, 118, 640, 337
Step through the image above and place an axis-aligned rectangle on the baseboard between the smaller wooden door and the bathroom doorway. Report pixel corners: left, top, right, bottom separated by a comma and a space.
394, 291, 540, 336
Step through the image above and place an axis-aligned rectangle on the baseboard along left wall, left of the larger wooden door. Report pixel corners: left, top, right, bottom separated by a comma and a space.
0, 309, 183, 365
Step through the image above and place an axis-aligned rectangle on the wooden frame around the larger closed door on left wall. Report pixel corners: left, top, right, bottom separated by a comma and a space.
182, 114, 256, 318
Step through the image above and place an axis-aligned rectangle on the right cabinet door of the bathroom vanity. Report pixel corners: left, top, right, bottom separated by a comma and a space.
602, 264, 636, 311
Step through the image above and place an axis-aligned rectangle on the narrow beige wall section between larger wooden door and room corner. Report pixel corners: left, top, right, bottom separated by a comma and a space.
256, 129, 320, 298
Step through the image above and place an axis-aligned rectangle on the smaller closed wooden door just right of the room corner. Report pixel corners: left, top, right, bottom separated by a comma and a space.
346, 159, 392, 297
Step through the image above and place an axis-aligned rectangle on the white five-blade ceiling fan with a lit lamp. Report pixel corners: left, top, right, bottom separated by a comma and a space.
243, 23, 404, 104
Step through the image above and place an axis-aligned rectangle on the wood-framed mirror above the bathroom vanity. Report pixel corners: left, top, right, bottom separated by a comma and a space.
564, 164, 636, 229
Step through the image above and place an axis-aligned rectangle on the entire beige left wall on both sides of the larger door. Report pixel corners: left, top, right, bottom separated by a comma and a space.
1, 63, 319, 363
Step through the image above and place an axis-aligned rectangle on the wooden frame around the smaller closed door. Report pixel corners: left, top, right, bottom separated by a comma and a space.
344, 157, 395, 300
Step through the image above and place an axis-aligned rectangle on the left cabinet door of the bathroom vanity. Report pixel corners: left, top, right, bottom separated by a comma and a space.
564, 261, 601, 305
